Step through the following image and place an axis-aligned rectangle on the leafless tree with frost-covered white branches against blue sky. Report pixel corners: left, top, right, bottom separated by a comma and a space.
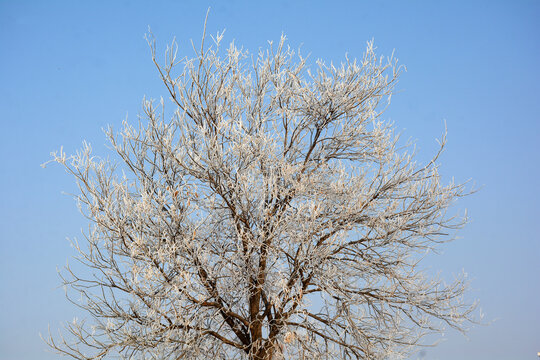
48, 28, 474, 360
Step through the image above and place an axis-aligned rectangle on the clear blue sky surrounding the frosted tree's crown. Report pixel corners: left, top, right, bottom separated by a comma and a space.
0, 0, 540, 360
